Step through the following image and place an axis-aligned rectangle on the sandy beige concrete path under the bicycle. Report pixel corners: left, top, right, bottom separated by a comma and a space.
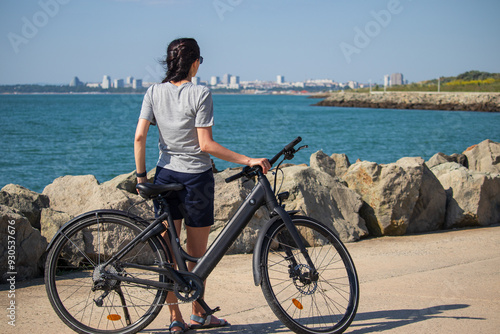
0, 226, 500, 334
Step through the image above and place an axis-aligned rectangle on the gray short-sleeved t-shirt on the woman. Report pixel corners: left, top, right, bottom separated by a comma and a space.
139, 82, 214, 174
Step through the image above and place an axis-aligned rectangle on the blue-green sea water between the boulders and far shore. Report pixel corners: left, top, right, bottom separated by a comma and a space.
0, 94, 500, 192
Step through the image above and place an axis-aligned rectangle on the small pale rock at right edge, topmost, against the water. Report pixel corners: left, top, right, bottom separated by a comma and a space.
463, 139, 500, 173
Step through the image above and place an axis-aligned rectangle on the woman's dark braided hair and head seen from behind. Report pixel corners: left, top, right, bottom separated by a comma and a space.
162, 38, 200, 82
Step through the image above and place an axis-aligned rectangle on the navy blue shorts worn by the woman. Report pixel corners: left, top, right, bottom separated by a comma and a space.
154, 167, 214, 227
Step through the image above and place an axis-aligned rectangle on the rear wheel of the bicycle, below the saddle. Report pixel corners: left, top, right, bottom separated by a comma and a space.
45, 213, 169, 334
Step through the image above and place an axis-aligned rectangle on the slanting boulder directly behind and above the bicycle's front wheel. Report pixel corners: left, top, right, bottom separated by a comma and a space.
269, 166, 368, 242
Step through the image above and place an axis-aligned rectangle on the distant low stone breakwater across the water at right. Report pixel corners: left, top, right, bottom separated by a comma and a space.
312, 92, 500, 112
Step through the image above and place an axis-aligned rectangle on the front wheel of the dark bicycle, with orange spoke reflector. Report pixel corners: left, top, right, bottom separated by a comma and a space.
261, 216, 359, 334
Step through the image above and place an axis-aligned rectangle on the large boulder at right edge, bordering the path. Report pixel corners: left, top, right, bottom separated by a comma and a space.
432, 162, 500, 228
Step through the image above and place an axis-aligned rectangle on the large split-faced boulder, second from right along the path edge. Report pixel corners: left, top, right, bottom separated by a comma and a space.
344, 158, 446, 236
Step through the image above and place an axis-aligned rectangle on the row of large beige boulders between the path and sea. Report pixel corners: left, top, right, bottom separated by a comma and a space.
0, 140, 500, 280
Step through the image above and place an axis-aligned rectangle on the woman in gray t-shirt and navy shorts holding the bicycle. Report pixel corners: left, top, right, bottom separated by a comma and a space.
134, 38, 271, 333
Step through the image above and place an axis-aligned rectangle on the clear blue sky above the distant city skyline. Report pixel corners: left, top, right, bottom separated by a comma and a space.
0, 0, 500, 84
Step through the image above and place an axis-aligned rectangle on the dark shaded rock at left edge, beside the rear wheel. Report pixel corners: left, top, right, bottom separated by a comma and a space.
0, 205, 47, 282
